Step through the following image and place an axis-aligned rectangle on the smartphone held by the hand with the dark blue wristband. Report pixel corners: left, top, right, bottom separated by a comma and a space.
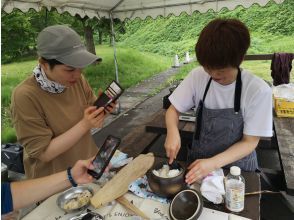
88, 135, 120, 179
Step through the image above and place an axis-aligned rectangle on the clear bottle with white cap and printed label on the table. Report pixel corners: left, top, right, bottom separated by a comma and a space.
225, 166, 245, 212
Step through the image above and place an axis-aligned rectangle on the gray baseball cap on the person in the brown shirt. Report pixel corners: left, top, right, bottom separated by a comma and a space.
37, 25, 102, 68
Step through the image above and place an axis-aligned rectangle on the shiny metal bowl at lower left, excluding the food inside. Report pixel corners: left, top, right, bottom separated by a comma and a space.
56, 186, 94, 213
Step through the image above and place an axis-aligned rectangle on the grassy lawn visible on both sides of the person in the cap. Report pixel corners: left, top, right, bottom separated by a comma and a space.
1, 46, 172, 143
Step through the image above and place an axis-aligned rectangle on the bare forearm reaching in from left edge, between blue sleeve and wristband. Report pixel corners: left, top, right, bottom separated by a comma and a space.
11, 171, 71, 210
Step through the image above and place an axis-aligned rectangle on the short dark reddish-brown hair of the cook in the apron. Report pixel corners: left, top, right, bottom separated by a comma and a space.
195, 18, 250, 69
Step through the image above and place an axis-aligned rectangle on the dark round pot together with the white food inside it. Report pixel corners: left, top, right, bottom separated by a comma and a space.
147, 161, 186, 198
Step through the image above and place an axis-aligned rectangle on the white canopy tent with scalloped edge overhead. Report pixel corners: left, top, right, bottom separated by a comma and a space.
1, 0, 284, 20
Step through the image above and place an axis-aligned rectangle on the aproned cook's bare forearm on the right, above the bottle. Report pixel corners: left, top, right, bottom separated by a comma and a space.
212, 135, 260, 168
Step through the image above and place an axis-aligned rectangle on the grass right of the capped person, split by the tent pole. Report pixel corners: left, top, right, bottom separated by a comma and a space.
84, 46, 172, 91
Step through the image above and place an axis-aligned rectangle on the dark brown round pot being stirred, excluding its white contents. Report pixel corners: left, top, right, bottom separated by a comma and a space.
147, 161, 186, 198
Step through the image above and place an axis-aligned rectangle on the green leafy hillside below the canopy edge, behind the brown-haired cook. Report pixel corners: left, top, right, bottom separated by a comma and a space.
119, 0, 294, 57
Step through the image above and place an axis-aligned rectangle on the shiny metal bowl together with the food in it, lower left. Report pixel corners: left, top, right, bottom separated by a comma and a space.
56, 186, 94, 213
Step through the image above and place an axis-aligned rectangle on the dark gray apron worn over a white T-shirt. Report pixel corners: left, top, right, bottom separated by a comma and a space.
188, 68, 258, 171
